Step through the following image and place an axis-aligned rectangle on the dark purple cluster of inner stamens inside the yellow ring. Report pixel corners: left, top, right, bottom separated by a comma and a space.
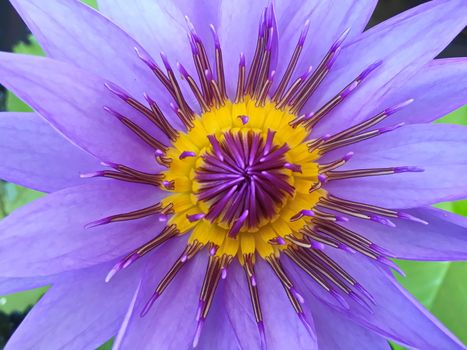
195, 130, 294, 232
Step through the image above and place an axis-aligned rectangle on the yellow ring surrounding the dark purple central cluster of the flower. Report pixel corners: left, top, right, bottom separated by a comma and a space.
162, 98, 324, 263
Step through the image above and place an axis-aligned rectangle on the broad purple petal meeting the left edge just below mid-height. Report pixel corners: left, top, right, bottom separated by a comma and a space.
0, 181, 164, 277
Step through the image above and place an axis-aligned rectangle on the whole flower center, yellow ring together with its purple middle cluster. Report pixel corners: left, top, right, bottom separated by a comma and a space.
159, 97, 322, 256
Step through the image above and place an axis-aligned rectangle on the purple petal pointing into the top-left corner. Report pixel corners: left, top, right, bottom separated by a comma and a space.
12, 0, 177, 123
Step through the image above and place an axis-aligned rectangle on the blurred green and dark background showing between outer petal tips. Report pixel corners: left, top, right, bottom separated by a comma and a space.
0, 0, 467, 350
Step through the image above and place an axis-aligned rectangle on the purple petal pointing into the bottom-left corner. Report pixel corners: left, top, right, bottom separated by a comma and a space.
6, 264, 141, 349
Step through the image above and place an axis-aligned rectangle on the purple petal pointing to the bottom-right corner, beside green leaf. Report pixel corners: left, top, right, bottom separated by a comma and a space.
327, 248, 464, 350
